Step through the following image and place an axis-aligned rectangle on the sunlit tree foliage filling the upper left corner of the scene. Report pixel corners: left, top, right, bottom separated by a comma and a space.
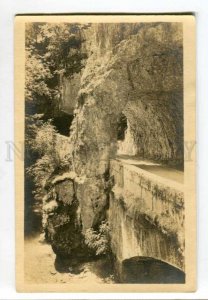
25, 23, 86, 116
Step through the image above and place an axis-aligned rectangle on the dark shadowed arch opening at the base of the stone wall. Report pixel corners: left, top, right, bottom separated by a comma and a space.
121, 256, 185, 284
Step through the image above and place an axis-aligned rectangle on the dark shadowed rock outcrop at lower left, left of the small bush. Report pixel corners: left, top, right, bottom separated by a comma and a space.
43, 179, 85, 258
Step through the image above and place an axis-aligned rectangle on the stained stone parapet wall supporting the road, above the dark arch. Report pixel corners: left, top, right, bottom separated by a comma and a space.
109, 160, 185, 270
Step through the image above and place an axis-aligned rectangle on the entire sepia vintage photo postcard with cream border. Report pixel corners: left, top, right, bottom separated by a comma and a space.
15, 15, 196, 292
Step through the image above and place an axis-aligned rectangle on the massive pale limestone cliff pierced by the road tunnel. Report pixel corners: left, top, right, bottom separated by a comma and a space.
68, 23, 183, 232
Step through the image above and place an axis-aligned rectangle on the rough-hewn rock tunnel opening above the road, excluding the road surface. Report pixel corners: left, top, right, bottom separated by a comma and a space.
114, 93, 183, 171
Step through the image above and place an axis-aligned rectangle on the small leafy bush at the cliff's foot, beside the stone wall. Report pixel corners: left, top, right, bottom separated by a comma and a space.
85, 222, 111, 255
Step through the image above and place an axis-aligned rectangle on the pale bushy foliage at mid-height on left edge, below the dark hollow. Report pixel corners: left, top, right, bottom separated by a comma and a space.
26, 115, 70, 198
